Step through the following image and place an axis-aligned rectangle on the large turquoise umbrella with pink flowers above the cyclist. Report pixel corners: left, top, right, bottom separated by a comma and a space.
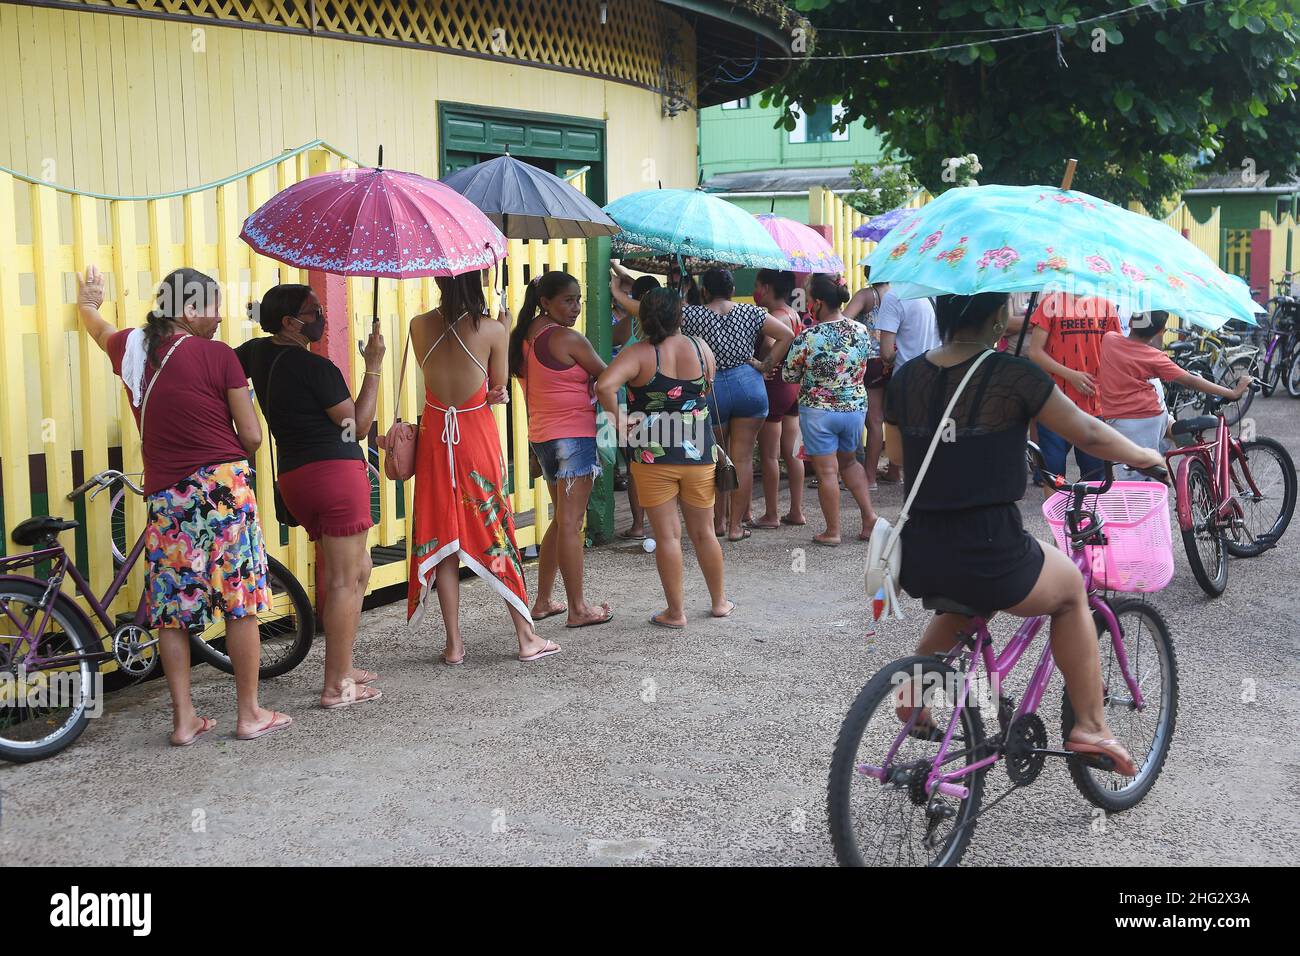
863, 186, 1264, 325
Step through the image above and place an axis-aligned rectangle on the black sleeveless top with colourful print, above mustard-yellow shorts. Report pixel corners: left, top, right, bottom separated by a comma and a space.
628, 338, 718, 464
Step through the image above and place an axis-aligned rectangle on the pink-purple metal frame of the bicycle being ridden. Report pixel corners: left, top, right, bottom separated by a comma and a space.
858, 545, 1144, 800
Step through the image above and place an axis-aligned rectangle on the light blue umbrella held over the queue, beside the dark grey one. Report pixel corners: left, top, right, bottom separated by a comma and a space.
605, 189, 790, 272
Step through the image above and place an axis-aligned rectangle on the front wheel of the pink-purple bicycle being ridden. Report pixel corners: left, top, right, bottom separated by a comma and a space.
1061, 598, 1178, 813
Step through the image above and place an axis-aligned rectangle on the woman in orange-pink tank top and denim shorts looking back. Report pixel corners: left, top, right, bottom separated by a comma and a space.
510, 271, 614, 627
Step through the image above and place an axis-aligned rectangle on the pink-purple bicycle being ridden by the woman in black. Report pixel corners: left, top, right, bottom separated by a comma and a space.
828, 442, 1178, 866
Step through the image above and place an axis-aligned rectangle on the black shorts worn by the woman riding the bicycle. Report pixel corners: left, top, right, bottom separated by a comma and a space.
898, 503, 1043, 611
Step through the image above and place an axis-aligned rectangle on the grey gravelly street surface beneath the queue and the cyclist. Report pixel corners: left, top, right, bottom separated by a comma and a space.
0, 395, 1300, 865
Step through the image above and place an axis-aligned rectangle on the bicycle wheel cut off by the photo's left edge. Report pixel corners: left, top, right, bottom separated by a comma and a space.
0, 580, 99, 763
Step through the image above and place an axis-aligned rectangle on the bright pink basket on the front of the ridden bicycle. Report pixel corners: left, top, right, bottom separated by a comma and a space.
1043, 481, 1174, 592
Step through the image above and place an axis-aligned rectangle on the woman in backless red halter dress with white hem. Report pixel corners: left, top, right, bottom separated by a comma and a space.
407, 272, 560, 665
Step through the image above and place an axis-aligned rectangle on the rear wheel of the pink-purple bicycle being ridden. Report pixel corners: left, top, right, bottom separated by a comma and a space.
827, 656, 985, 866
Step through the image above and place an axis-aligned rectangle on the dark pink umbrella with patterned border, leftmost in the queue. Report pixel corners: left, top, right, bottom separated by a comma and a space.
239, 161, 506, 278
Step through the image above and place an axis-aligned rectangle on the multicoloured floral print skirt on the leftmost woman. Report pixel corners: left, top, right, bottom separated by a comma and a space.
144, 460, 270, 631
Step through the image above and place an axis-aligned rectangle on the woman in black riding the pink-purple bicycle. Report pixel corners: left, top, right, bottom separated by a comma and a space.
885, 293, 1164, 777
